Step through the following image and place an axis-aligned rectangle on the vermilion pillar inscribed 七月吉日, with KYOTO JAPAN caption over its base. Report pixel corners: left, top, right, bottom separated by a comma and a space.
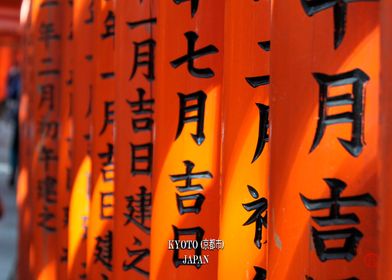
150, 1, 225, 279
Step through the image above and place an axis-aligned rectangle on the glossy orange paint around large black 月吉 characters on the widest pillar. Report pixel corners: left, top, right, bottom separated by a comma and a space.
268, 1, 380, 279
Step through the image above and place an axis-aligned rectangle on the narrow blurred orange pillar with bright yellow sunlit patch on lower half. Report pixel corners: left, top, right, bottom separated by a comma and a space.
68, 0, 95, 279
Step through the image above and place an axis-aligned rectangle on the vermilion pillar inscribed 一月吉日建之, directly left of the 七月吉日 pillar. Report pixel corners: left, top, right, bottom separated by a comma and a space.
113, 0, 158, 279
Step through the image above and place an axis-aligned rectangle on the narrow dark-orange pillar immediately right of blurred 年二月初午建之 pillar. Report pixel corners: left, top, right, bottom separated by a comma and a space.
57, 1, 75, 279
